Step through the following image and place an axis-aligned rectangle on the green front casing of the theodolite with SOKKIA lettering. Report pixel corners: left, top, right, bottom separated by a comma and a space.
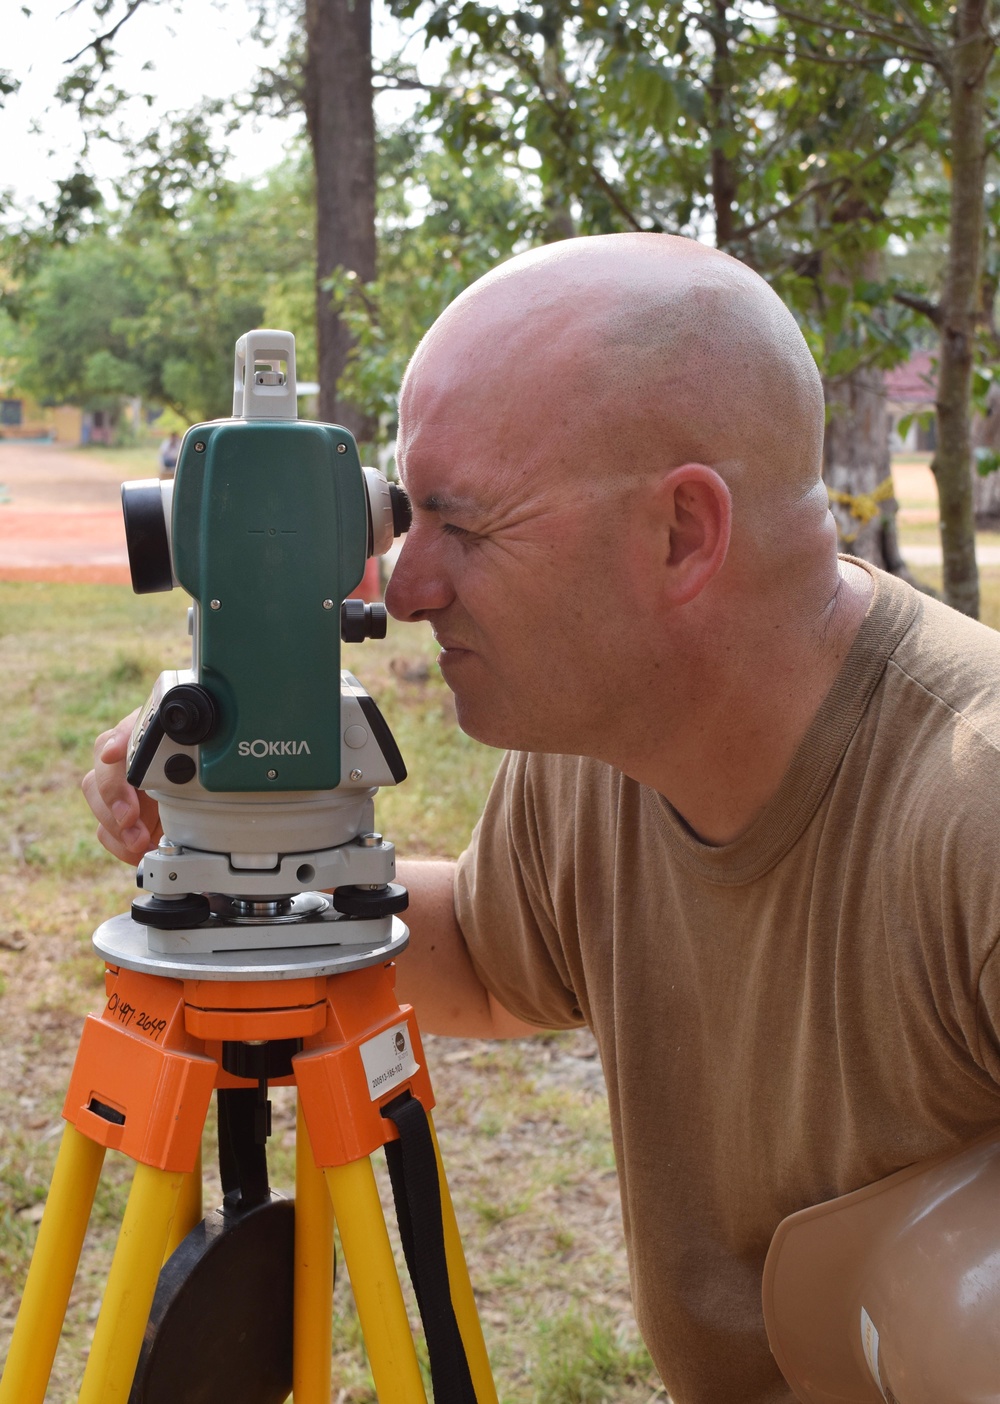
171, 420, 368, 792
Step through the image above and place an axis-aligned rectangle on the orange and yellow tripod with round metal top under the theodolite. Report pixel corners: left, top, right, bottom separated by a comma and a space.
0, 917, 497, 1404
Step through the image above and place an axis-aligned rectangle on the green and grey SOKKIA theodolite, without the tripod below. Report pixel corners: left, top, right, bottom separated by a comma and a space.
97, 330, 409, 958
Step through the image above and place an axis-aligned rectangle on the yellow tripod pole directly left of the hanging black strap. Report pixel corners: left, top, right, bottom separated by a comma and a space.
323, 1160, 427, 1404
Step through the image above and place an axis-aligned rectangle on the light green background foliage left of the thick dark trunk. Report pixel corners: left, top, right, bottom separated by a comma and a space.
0, 166, 315, 420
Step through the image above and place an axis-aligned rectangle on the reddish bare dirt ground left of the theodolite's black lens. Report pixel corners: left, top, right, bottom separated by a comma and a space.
0, 441, 129, 584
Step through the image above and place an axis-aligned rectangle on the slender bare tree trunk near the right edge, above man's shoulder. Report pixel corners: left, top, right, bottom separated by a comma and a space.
931, 0, 993, 618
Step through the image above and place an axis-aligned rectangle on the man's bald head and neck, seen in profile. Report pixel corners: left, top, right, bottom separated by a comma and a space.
386, 234, 871, 819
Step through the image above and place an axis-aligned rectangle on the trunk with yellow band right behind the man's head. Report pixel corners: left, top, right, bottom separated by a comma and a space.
823, 366, 904, 573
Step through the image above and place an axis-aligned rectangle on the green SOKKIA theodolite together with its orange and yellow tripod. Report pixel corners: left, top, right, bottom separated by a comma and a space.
0, 330, 496, 1404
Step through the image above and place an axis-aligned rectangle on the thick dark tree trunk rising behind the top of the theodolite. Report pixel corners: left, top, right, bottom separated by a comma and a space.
305, 0, 375, 439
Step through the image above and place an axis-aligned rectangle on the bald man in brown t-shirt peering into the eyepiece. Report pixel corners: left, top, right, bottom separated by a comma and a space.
84, 234, 1000, 1404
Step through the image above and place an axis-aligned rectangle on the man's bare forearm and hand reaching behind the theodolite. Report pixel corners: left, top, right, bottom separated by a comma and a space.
83, 712, 538, 1039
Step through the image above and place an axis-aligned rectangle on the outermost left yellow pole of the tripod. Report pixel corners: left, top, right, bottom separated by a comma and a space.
0, 1123, 104, 1404
